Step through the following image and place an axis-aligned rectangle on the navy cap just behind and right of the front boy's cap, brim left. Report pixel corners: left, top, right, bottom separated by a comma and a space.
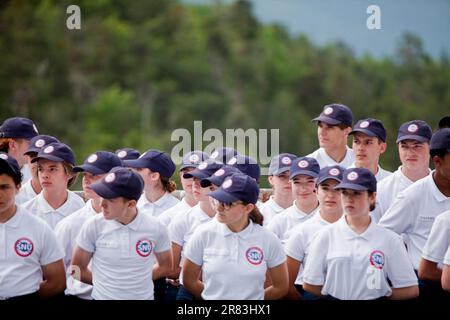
123, 149, 176, 178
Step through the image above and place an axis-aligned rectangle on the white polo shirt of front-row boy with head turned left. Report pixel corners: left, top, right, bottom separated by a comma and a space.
77, 212, 170, 300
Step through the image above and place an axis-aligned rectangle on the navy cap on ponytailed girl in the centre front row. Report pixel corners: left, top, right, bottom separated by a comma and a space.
208, 173, 259, 204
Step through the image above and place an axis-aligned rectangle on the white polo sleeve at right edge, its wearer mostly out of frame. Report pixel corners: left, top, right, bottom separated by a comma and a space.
422, 214, 450, 263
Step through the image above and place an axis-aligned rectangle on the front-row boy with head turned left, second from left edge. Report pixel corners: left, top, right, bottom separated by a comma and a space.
72, 167, 172, 300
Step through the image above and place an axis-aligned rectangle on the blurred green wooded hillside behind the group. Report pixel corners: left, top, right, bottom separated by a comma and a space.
0, 0, 450, 188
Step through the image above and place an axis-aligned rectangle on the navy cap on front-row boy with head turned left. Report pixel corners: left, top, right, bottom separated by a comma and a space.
91, 167, 144, 201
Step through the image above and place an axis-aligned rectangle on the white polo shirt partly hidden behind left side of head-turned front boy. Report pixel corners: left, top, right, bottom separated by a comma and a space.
55, 200, 101, 300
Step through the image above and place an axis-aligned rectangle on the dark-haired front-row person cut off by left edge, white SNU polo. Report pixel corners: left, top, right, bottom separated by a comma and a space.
0, 152, 66, 301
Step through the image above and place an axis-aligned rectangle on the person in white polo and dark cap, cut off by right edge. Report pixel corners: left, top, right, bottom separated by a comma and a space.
379, 128, 450, 299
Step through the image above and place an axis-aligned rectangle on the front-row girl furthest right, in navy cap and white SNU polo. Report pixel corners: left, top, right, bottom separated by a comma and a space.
303, 168, 419, 300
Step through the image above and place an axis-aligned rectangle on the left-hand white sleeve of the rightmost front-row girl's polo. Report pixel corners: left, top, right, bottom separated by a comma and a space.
303, 229, 328, 286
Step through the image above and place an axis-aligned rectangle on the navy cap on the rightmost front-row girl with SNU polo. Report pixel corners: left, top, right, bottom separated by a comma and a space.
334, 168, 377, 192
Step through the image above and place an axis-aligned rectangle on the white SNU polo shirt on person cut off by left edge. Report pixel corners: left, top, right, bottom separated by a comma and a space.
0, 206, 64, 298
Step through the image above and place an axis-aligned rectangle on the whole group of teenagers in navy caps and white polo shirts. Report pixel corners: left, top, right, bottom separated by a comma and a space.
0, 110, 450, 299
